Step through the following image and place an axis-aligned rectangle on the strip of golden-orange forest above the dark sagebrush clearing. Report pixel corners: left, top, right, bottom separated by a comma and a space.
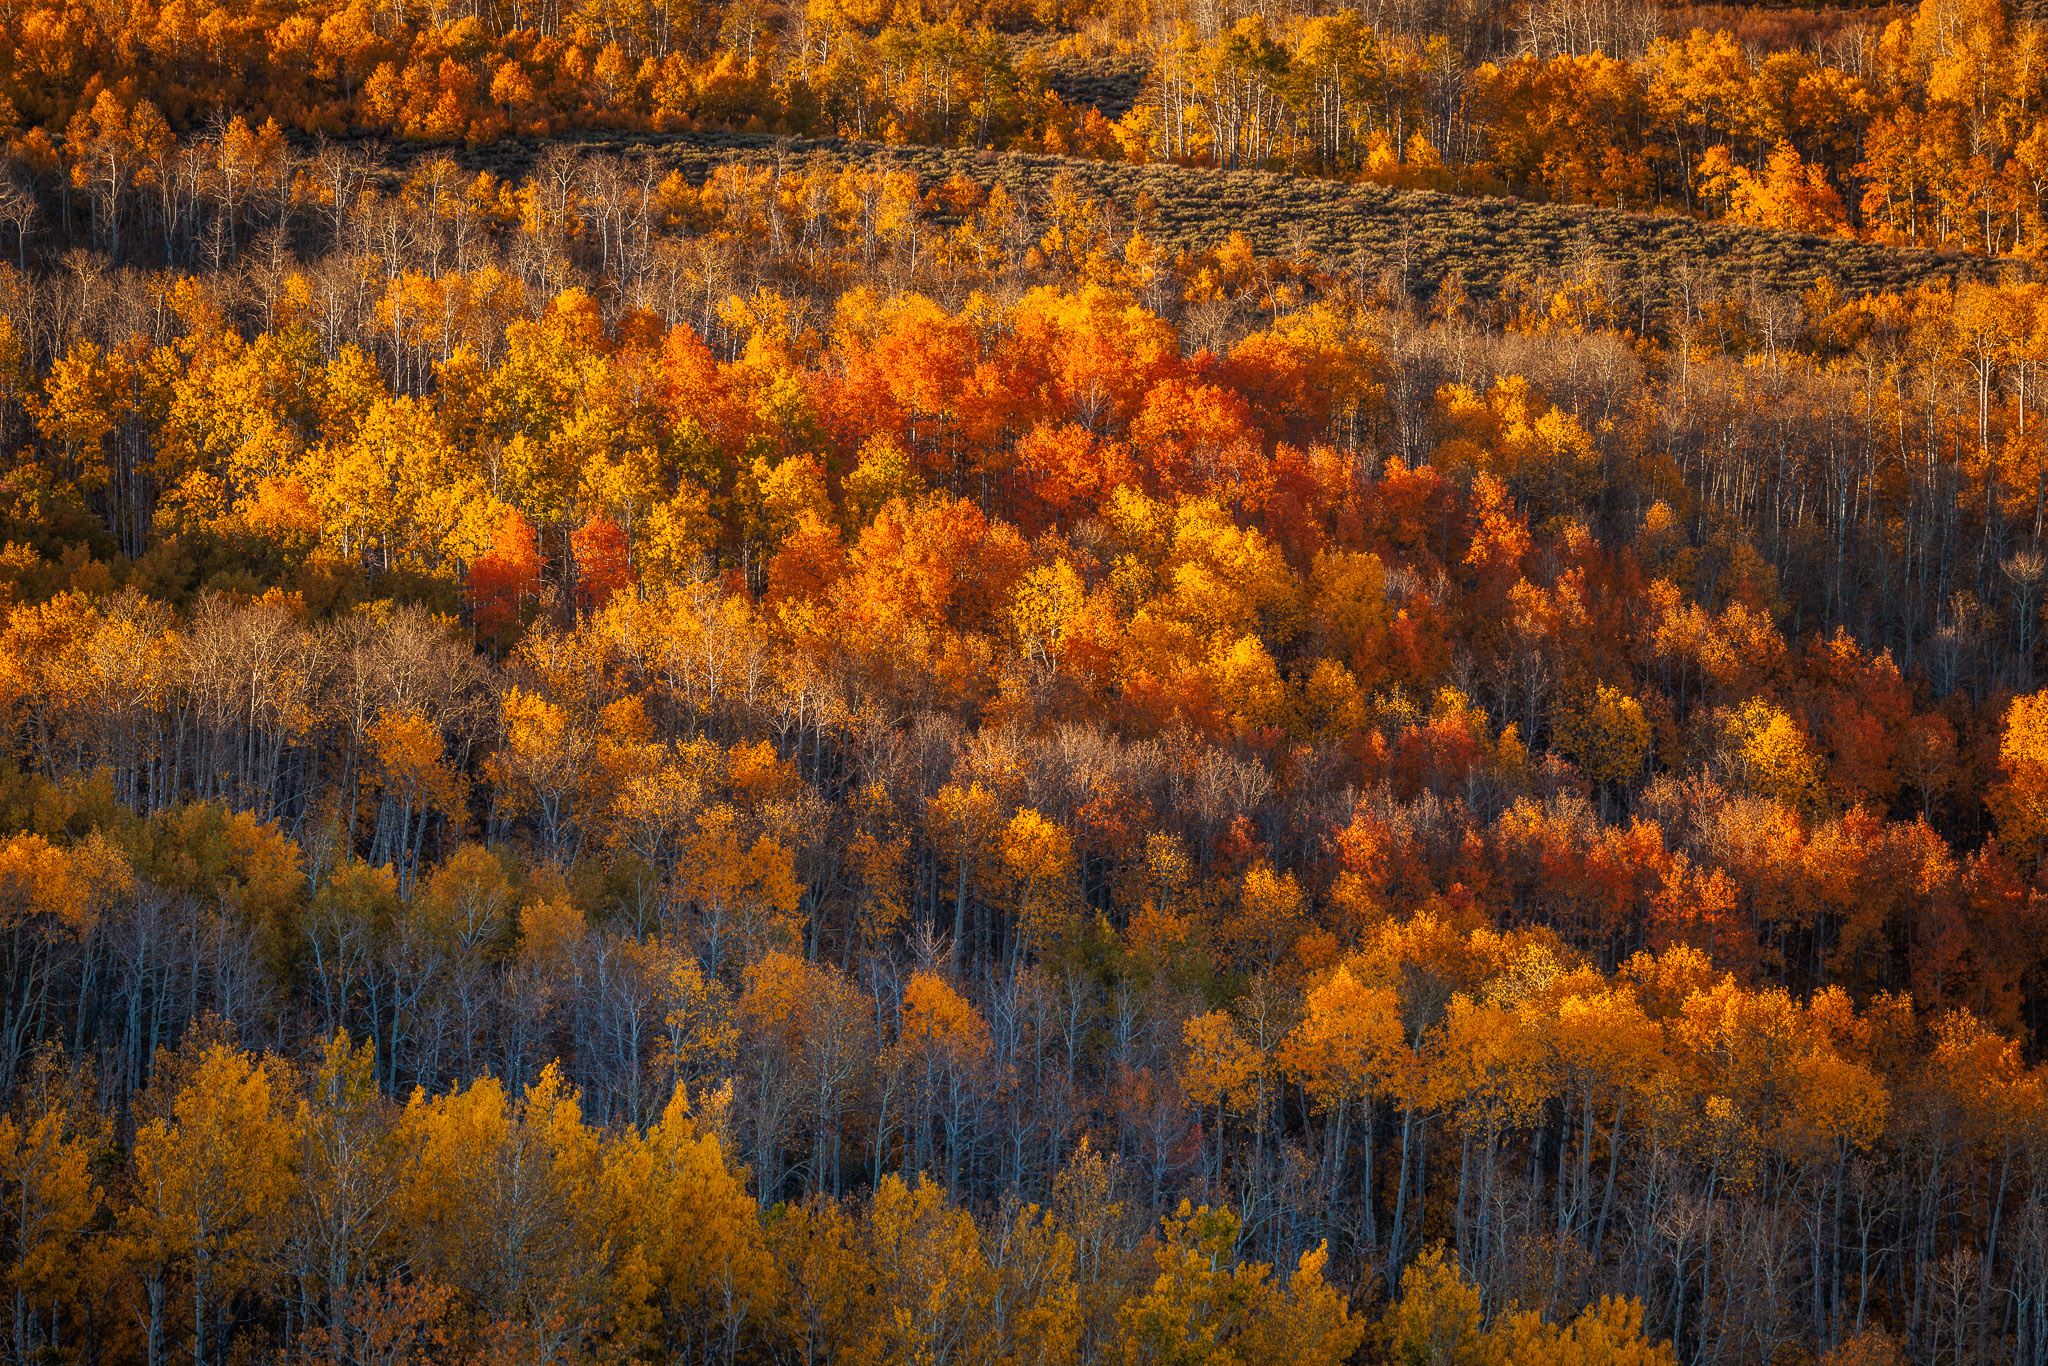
12, 0, 2048, 249
